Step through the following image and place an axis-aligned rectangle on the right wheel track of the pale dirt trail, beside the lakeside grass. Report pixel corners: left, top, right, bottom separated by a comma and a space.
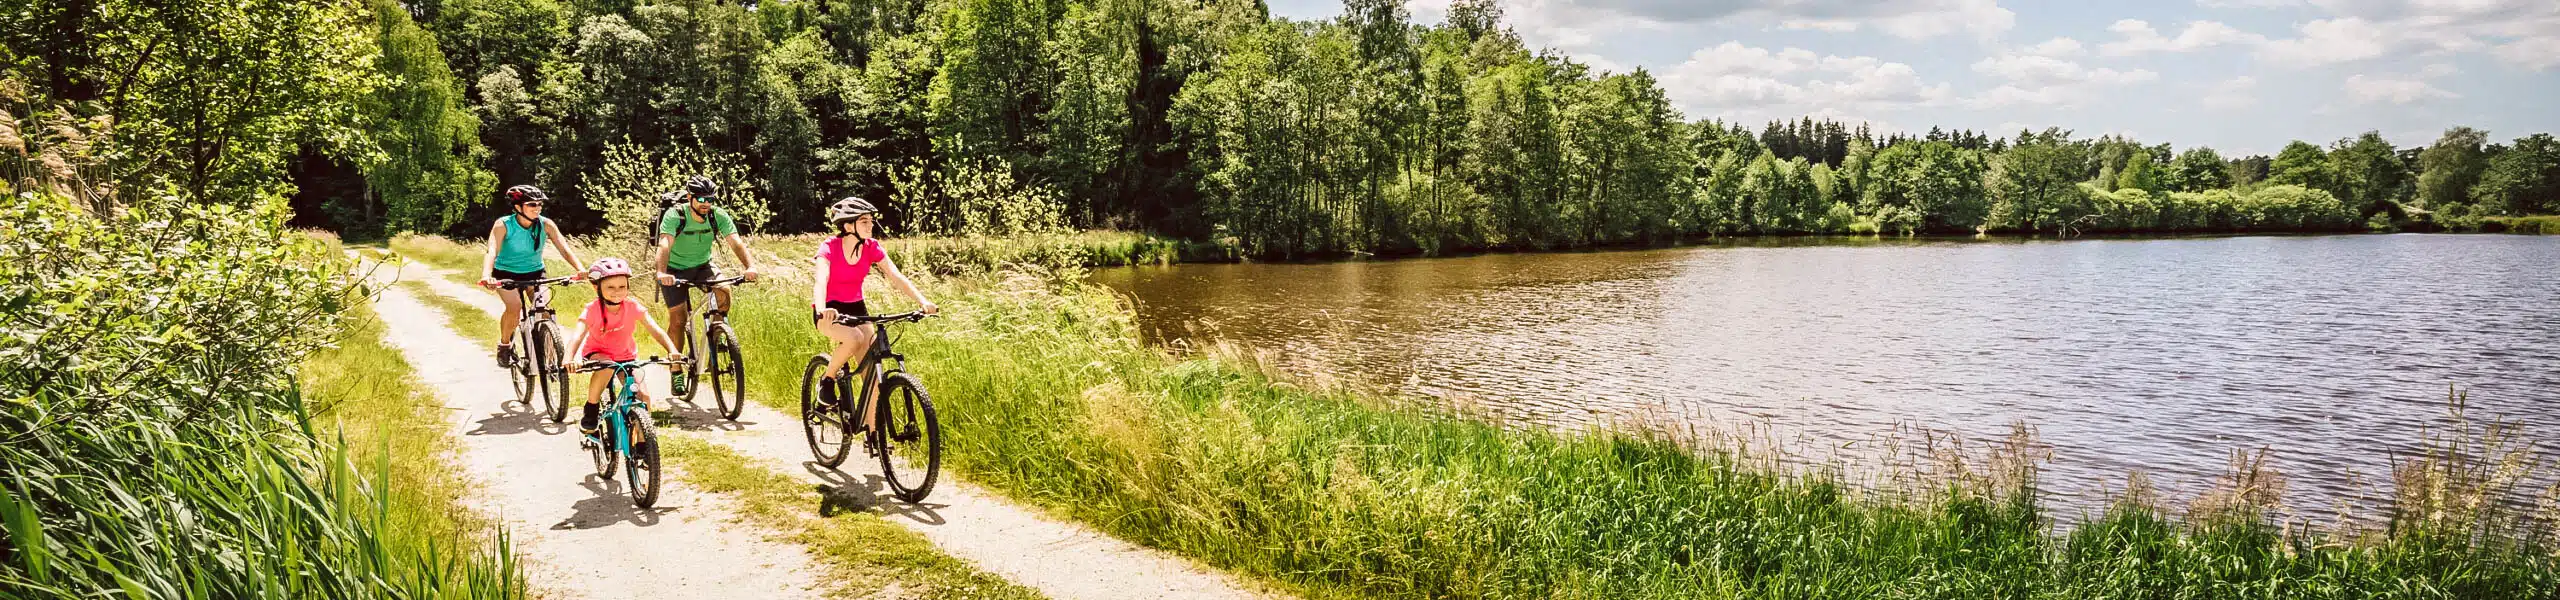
384, 255, 1280, 600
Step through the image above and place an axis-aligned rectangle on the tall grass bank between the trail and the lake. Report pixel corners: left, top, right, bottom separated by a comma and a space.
384, 241, 2560, 597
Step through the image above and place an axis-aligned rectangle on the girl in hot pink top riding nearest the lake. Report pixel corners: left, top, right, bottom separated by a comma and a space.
809, 197, 942, 426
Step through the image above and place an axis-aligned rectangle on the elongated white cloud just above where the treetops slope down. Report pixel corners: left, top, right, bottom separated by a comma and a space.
1661, 41, 1951, 121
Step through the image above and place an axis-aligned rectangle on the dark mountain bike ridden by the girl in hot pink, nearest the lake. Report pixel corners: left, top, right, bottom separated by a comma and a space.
801, 313, 942, 503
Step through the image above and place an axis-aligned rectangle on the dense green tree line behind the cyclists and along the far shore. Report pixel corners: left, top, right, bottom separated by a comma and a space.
5, 0, 2560, 256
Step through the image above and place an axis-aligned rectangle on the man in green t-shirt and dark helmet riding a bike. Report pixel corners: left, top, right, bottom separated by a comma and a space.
655, 174, 755, 395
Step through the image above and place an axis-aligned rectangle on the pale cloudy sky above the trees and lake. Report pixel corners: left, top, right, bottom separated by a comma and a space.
1267, 0, 2560, 156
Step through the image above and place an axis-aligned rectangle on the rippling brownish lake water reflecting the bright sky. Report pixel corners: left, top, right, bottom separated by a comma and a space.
1093, 236, 2560, 515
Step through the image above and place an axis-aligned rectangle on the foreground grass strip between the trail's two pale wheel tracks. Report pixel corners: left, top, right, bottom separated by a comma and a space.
666, 433, 1042, 600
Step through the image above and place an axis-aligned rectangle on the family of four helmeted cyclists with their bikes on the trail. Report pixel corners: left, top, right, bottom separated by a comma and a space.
479, 177, 940, 505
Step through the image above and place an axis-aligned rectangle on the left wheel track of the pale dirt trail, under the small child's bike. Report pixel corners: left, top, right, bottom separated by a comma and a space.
374, 264, 817, 597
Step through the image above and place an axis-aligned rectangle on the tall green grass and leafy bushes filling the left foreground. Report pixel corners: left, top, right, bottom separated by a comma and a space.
0, 195, 522, 597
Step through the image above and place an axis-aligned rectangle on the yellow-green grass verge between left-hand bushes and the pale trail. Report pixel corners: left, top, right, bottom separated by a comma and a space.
300, 264, 525, 595
